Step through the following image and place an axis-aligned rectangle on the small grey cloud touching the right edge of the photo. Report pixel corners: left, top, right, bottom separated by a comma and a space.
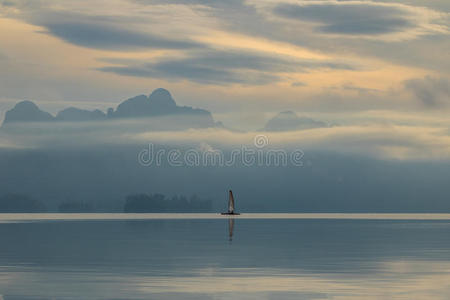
405, 76, 450, 108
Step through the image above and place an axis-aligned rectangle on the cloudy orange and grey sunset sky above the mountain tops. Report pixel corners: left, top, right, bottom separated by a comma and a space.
0, 0, 450, 156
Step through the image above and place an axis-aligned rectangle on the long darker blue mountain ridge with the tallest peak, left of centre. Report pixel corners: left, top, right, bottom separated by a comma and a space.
3, 88, 215, 129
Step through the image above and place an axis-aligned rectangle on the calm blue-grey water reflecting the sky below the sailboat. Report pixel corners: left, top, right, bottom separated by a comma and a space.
0, 214, 450, 300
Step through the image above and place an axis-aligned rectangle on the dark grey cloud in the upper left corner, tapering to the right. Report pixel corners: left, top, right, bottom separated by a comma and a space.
6, 2, 204, 51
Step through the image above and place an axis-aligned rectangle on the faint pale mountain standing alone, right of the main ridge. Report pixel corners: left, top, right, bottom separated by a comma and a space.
264, 111, 329, 131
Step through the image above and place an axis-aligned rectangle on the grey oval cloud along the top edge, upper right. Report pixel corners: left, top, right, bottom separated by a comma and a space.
274, 3, 414, 35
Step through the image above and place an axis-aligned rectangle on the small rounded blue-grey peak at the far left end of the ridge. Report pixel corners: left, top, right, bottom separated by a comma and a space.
3, 101, 55, 125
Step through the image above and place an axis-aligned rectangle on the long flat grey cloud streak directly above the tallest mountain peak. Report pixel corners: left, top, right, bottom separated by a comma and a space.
99, 50, 355, 85
